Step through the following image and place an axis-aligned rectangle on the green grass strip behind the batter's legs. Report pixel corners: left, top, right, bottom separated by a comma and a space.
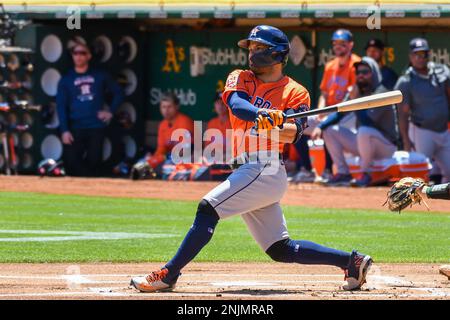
0, 192, 450, 262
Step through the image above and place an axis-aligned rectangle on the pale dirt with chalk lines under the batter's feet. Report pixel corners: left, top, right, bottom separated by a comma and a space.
0, 263, 450, 300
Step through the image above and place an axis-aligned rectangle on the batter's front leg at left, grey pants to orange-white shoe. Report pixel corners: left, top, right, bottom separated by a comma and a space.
131, 162, 287, 292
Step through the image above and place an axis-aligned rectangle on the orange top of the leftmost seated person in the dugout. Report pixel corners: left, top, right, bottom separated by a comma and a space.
148, 112, 194, 168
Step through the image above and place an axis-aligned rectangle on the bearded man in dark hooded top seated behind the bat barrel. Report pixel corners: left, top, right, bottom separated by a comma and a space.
311, 57, 398, 187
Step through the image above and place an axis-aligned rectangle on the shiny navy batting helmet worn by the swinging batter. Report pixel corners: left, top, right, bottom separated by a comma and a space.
238, 25, 290, 67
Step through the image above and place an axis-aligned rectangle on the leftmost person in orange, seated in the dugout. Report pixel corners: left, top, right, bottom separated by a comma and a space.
147, 92, 194, 172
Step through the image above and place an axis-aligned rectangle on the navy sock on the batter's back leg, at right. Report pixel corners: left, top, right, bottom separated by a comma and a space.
266, 239, 351, 269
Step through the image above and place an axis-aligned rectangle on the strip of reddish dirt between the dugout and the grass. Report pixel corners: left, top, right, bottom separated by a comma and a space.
0, 176, 450, 212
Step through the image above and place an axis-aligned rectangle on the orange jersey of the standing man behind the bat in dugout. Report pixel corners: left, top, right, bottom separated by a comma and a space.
320, 54, 361, 106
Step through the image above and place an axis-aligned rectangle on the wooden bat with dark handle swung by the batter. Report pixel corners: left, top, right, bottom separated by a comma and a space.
286, 90, 403, 119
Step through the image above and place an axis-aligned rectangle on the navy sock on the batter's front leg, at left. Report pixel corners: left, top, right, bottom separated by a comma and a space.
164, 212, 219, 282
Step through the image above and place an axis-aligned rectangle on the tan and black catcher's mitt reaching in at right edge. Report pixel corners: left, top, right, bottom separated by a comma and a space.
383, 178, 429, 213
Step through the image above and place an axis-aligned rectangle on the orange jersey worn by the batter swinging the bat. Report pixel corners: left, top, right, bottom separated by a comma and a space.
222, 70, 310, 156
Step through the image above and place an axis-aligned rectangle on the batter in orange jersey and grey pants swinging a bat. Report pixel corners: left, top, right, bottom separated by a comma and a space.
131, 25, 372, 292
